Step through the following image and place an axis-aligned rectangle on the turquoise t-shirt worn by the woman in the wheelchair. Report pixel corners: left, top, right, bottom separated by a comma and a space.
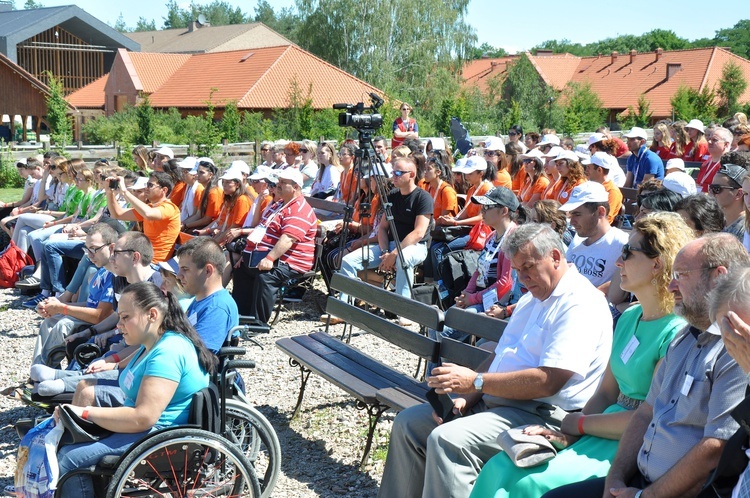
119, 332, 208, 427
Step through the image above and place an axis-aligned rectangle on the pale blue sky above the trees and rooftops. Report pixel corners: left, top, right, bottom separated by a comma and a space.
38, 0, 750, 53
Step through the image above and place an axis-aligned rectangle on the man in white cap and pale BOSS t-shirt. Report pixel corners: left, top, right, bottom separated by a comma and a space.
560, 181, 628, 290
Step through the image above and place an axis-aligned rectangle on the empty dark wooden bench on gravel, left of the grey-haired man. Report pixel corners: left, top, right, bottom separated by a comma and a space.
276, 274, 443, 464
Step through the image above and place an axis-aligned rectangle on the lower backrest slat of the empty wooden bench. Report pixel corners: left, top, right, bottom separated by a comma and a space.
326, 297, 439, 362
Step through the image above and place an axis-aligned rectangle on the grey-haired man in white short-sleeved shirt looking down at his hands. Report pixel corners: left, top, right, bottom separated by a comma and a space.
379, 223, 612, 498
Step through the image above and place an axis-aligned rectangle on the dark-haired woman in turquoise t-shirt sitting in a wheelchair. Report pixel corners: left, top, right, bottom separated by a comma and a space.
55, 282, 217, 496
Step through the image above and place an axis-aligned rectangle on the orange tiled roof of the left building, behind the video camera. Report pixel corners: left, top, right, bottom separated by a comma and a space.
150, 45, 380, 109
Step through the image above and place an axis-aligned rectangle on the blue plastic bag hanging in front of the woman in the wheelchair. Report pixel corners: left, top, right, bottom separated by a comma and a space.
15, 417, 63, 498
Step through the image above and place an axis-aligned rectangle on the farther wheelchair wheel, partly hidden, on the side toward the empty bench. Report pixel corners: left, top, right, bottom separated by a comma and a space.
227, 399, 281, 498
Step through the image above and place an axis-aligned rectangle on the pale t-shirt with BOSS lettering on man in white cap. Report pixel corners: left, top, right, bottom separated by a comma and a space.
565, 227, 628, 287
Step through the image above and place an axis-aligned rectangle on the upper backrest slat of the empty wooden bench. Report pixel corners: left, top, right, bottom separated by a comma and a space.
331, 273, 443, 330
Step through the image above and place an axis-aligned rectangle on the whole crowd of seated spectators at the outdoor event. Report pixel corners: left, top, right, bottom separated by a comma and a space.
0, 111, 750, 497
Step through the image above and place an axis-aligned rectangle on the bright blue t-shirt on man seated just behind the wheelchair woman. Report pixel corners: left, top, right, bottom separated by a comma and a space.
186, 289, 240, 353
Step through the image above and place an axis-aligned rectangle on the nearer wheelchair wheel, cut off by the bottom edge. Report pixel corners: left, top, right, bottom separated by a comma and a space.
107, 428, 260, 498
